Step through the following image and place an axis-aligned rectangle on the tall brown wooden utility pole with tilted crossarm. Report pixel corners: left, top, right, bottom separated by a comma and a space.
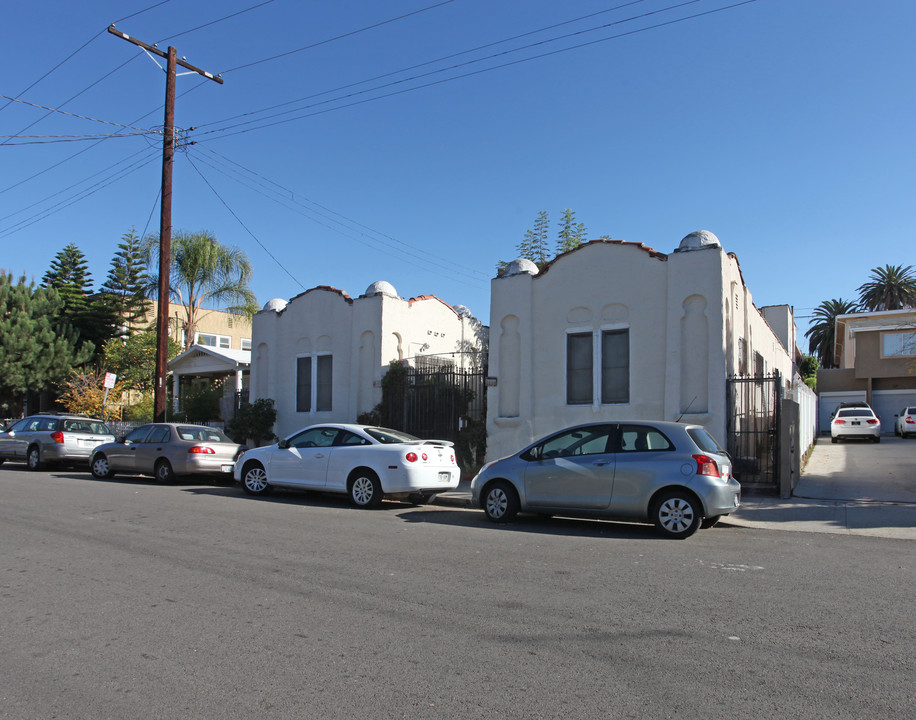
108, 25, 223, 422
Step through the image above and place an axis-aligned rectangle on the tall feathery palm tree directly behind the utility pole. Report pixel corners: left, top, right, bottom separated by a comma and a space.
150, 231, 258, 349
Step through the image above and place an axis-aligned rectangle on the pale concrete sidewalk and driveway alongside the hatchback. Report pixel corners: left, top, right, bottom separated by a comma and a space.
435, 437, 916, 540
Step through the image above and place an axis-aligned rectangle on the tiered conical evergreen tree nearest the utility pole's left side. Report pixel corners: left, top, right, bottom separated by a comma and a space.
101, 227, 150, 334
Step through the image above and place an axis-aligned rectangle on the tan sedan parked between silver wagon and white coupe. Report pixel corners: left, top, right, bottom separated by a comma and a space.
89, 423, 244, 482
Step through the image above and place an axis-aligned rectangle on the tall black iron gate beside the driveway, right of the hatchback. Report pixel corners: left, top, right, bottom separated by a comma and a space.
727, 373, 782, 491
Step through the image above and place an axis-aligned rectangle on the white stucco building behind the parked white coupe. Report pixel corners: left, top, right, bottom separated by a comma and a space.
250, 282, 487, 437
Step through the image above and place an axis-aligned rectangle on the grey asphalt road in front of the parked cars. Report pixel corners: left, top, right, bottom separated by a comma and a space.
0, 464, 916, 720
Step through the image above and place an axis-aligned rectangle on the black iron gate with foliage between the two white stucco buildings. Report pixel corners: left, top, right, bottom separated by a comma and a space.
380, 365, 487, 470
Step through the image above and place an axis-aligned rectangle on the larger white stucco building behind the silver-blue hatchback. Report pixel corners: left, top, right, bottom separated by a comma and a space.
487, 231, 795, 459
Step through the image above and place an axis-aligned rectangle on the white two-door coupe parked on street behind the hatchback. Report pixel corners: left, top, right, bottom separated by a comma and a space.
235, 423, 461, 508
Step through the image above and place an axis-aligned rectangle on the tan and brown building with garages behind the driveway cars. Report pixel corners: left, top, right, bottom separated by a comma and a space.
817, 308, 916, 433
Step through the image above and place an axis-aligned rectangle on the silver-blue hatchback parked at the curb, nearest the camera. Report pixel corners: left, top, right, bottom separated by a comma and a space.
471, 422, 741, 538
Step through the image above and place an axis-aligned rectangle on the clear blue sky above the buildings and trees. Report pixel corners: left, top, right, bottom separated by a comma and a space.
0, 0, 916, 344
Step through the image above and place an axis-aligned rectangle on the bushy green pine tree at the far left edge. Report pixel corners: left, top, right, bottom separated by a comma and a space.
0, 271, 92, 412
